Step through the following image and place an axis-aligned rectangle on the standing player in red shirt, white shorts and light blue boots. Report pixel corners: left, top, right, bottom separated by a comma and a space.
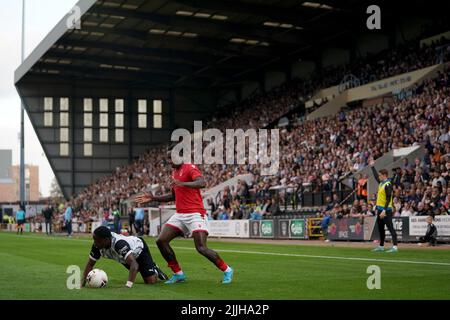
135, 158, 233, 284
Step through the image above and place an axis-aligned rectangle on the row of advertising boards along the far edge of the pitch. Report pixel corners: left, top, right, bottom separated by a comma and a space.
2, 215, 450, 242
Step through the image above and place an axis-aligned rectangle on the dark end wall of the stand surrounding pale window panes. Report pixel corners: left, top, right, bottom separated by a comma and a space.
18, 83, 216, 197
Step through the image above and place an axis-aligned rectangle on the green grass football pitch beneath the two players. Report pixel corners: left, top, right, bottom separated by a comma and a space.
0, 232, 450, 300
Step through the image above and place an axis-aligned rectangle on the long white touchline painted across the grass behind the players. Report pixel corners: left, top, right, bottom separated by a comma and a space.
3, 232, 450, 267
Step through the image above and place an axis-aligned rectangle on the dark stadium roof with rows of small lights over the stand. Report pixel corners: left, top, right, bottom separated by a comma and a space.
15, 0, 444, 88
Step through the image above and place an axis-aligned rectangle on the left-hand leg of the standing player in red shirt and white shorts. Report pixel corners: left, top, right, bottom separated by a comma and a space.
156, 221, 186, 284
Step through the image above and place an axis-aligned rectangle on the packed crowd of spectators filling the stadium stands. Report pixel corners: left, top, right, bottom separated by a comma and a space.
65, 36, 450, 219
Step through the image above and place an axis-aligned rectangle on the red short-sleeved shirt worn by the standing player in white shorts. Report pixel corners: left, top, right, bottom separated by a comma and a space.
172, 163, 206, 214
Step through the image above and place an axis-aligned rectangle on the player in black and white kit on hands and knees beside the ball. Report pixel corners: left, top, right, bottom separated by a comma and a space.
82, 226, 168, 288
